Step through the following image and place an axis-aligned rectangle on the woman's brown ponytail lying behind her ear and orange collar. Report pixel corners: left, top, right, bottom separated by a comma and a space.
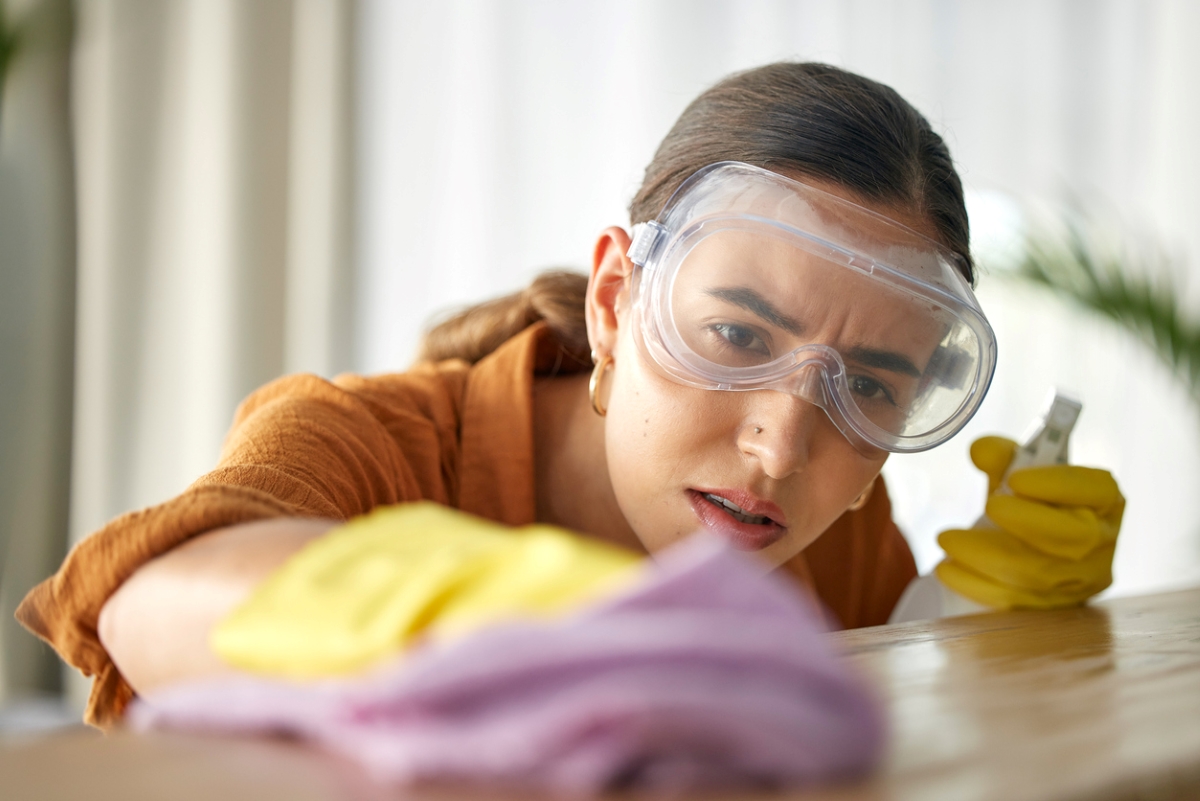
418, 270, 592, 366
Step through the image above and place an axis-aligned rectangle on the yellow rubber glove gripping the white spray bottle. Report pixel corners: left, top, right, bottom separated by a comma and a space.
935, 436, 1124, 609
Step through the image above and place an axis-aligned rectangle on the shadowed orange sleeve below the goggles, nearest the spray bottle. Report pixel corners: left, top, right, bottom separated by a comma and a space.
788, 476, 917, 628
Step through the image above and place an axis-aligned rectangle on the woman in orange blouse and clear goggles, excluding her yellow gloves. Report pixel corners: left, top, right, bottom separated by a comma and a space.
19, 64, 1115, 724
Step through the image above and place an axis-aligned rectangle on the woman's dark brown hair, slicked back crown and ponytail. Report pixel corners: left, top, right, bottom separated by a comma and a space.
420, 62, 974, 363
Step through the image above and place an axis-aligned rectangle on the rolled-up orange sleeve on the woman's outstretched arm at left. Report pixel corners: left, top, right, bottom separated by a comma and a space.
17, 366, 464, 727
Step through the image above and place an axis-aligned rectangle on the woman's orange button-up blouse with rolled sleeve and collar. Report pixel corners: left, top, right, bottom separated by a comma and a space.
17, 324, 917, 727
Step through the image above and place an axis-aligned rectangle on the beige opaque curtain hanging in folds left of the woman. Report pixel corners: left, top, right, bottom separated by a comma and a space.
71, 0, 354, 705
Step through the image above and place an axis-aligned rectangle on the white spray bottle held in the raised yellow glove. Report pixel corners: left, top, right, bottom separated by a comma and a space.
888, 391, 1082, 624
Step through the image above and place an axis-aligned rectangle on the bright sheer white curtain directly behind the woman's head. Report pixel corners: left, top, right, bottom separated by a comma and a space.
356, 0, 1200, 592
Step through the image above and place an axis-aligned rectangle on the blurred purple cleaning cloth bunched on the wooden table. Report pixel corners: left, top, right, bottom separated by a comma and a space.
128, 537, 884, 793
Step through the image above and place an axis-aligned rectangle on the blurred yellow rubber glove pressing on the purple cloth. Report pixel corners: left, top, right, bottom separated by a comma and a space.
210, 502, 642, 679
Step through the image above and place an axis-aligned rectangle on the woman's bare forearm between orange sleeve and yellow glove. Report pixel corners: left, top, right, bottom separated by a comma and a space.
92, 518, 337, 693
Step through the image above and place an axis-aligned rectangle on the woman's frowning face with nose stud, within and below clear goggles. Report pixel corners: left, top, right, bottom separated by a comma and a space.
588, 187, 936, 565
